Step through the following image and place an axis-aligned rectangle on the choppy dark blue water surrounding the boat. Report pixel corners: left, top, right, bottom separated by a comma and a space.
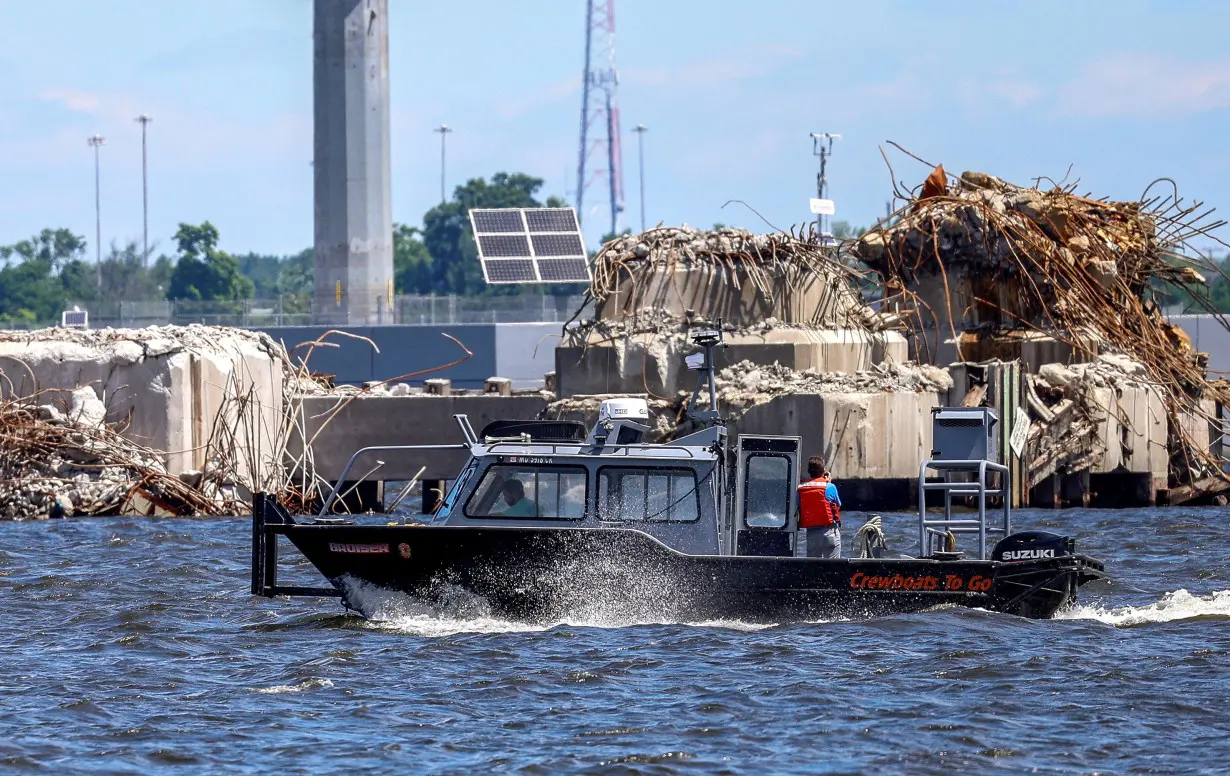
0, 509, 1230, 775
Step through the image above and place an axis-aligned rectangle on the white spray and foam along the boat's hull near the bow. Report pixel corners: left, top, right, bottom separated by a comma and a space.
344, 579, 776, 638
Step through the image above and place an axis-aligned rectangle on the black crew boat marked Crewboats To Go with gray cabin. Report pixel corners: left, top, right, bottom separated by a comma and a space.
252, 331, 1105, 622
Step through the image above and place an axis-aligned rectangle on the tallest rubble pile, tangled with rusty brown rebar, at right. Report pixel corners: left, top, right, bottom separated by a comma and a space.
852, 165, 1230, 487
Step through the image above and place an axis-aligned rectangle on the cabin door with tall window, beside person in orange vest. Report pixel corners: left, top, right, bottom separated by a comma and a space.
733, 434, 802, 557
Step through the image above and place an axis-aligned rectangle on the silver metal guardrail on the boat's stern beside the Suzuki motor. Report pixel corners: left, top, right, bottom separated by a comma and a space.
919, 460, 1012, 561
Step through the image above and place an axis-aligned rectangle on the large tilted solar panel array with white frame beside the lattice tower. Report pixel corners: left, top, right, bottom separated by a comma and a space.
470, 208, 592, 283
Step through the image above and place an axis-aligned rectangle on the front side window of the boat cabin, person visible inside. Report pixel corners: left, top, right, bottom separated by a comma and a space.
465, 464, 585, 520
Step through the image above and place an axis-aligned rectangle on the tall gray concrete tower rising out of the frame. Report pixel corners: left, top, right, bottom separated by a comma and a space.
312, 0, 392, 325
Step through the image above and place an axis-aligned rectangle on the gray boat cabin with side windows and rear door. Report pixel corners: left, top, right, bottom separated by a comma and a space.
432, 398, 800, 556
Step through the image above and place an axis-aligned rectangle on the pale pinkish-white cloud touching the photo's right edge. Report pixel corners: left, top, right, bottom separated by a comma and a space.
1057, 53, 1230, 118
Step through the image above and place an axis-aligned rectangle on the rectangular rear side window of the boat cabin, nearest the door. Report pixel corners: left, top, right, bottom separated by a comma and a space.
598, 466, 700, 523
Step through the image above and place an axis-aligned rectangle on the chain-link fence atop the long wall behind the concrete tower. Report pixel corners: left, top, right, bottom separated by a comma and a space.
40, 294, 584, 328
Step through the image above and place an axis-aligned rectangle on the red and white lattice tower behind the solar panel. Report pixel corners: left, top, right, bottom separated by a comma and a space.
577, 0, 624, 234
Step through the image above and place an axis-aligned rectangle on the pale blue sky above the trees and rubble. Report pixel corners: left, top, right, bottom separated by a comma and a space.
0, 0, 1230, 253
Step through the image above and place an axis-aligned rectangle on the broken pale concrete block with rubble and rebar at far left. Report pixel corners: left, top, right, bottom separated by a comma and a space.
0, 326, 287, 519
